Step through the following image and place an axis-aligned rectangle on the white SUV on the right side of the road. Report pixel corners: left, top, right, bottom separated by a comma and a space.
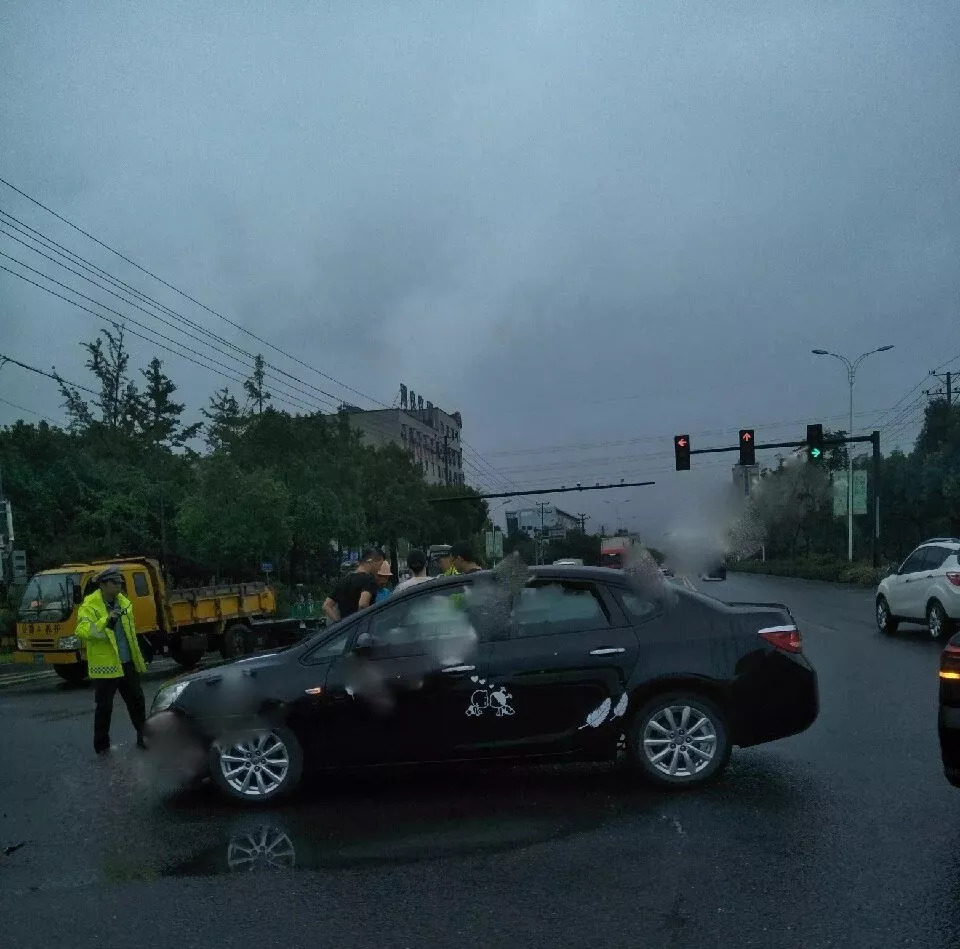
877, 537, 960, 639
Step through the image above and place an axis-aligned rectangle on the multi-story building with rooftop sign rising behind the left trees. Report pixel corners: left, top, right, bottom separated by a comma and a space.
341, 385, 464, 485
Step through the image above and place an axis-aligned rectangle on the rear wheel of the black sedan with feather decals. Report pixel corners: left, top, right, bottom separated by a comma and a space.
627, 692, 731, 788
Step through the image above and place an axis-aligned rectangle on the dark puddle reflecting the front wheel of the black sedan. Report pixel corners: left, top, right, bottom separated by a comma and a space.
159, 772, 635, 876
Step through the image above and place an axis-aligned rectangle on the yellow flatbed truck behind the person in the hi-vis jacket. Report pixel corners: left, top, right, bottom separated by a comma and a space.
13, 557, 304, 682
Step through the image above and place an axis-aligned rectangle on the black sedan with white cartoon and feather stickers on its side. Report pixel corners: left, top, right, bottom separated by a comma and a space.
148, 567, 818, 802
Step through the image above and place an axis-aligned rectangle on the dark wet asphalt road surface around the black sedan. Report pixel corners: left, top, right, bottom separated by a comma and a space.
0, 575, 960, 949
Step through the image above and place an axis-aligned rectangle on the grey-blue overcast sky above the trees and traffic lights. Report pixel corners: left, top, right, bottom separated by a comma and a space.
0, 0, 960, 534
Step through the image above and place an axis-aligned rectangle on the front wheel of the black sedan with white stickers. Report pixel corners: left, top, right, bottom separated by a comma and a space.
210, 728, 303, 804
